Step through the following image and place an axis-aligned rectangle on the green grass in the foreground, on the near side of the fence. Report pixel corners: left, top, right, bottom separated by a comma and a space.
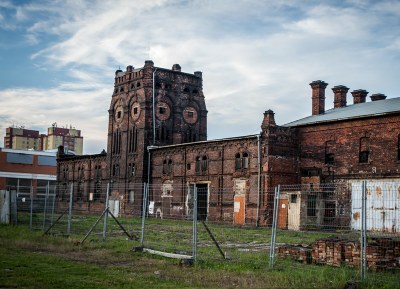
0, 223, 400, 288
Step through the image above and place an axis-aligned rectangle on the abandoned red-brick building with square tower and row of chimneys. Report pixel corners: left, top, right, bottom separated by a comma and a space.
57, 61, 400, 224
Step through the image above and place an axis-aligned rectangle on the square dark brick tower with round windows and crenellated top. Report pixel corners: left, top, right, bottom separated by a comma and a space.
107, 60, 207, 184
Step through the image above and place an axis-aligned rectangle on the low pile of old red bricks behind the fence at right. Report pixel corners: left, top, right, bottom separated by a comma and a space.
278, 238, 400, 271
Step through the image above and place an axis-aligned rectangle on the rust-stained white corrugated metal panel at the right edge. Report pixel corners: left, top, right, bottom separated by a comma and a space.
351, 180, 400, 233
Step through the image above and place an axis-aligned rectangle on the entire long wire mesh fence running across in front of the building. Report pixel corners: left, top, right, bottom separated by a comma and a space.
1, 180, 400, 279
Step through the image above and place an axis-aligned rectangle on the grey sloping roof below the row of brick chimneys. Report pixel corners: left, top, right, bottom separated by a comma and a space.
283, 97, 400, 127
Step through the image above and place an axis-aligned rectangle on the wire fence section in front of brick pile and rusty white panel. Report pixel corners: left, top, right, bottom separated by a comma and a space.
270, 180, 400, 279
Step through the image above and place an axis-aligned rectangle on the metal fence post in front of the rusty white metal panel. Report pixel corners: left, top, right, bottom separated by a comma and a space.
360, 181, 367, 280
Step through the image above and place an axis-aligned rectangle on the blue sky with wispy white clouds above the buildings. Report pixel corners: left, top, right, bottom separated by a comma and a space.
0, 0, 400, 154
